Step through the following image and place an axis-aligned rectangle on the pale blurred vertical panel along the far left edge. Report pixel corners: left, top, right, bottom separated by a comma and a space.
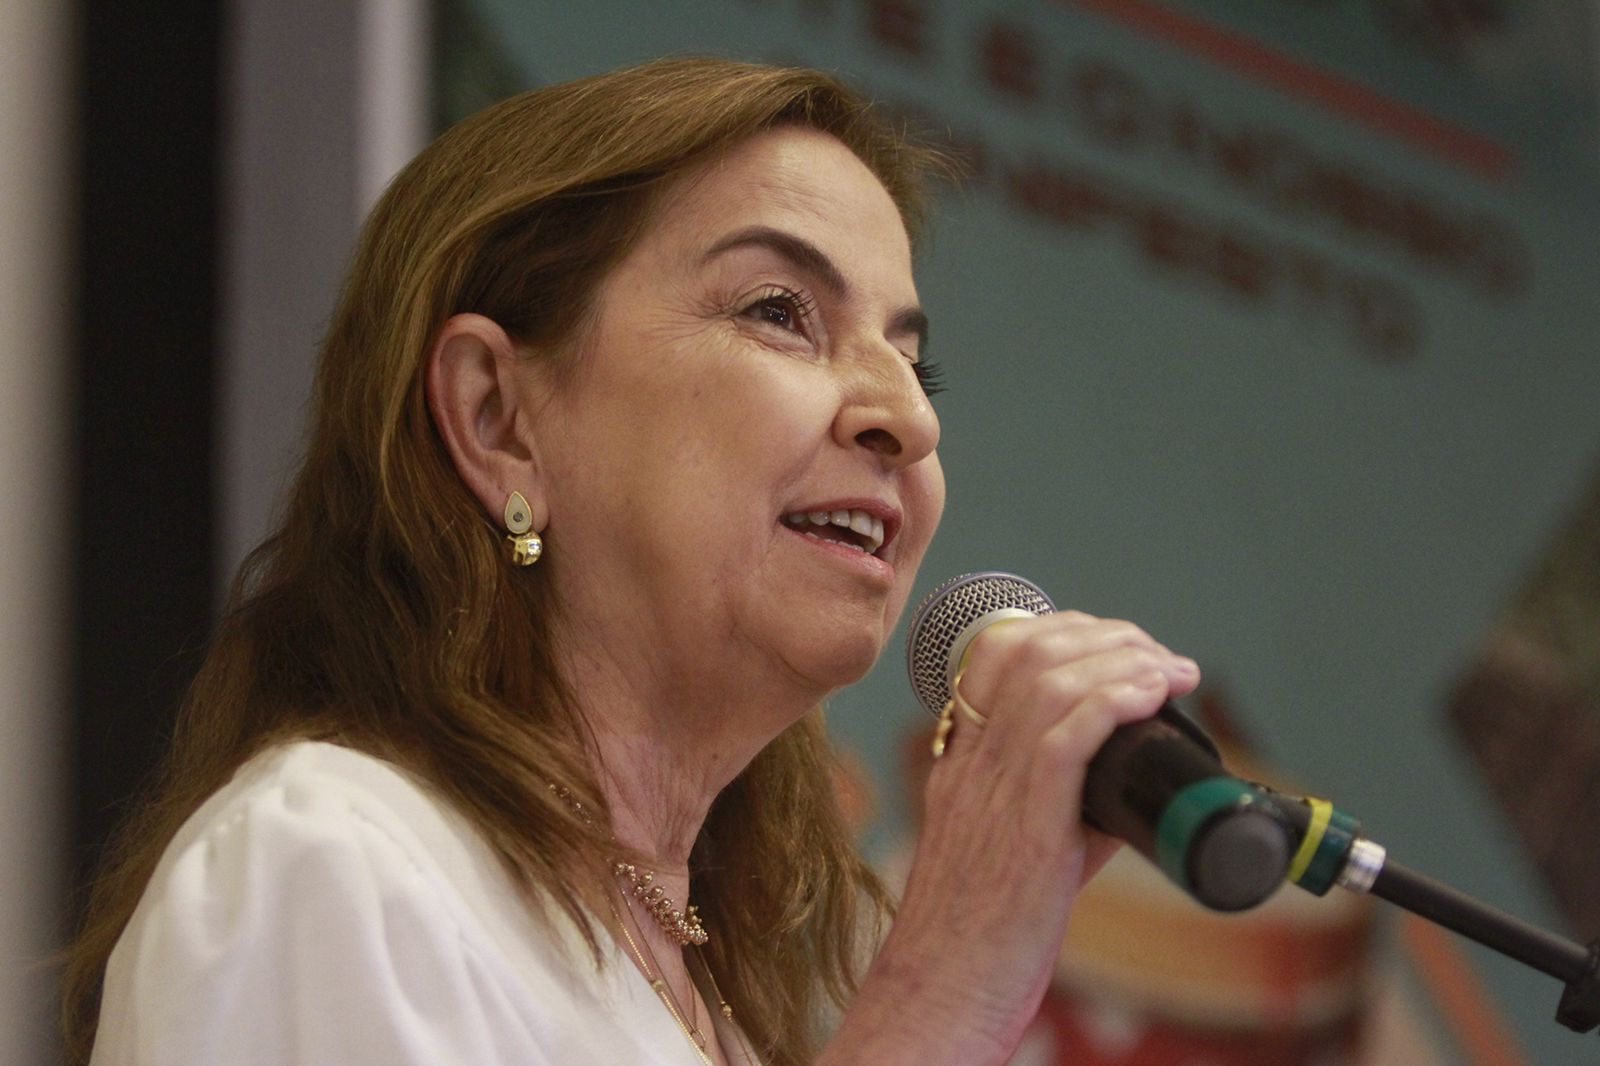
0, 0, 70, 1063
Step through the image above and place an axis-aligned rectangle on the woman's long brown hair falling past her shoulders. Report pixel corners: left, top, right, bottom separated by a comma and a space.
64, 59, 944, 1066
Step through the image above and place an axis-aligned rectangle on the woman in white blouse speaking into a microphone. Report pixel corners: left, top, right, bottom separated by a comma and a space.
67, 59, 1197, 1066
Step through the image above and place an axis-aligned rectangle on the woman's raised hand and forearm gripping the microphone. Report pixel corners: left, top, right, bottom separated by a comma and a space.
858, 573, 1200, 1063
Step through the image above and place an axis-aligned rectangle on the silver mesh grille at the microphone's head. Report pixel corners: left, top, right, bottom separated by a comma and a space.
906, 570, 1056, 714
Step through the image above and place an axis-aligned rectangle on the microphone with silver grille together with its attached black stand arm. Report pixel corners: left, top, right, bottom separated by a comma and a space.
906, 570, 1600, 1032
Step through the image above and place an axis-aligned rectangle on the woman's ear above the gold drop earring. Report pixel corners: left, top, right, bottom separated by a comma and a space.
424, 314, 549, 530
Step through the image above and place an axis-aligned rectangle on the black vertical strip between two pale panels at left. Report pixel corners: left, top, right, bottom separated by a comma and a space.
72, 0, 222, 896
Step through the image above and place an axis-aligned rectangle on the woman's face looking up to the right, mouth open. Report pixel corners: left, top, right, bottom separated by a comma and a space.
533, 130, 944, 695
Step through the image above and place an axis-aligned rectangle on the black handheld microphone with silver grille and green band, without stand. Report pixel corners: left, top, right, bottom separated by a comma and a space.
906, 570, 1299, 911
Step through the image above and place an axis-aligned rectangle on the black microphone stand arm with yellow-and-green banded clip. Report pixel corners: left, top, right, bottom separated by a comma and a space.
1262, 789, 1600, 1032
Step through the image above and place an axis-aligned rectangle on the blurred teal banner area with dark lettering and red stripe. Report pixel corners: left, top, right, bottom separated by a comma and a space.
440, 0, 1600, 1063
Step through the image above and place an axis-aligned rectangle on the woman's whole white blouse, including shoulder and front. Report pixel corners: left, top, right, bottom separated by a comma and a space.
91, 741, 728, 1066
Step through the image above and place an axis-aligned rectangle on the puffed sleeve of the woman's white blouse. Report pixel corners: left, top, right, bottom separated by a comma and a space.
93, 765, 549, 1066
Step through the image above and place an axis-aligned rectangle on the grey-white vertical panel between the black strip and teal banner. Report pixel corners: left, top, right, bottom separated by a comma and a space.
218, 0, 427, 589
